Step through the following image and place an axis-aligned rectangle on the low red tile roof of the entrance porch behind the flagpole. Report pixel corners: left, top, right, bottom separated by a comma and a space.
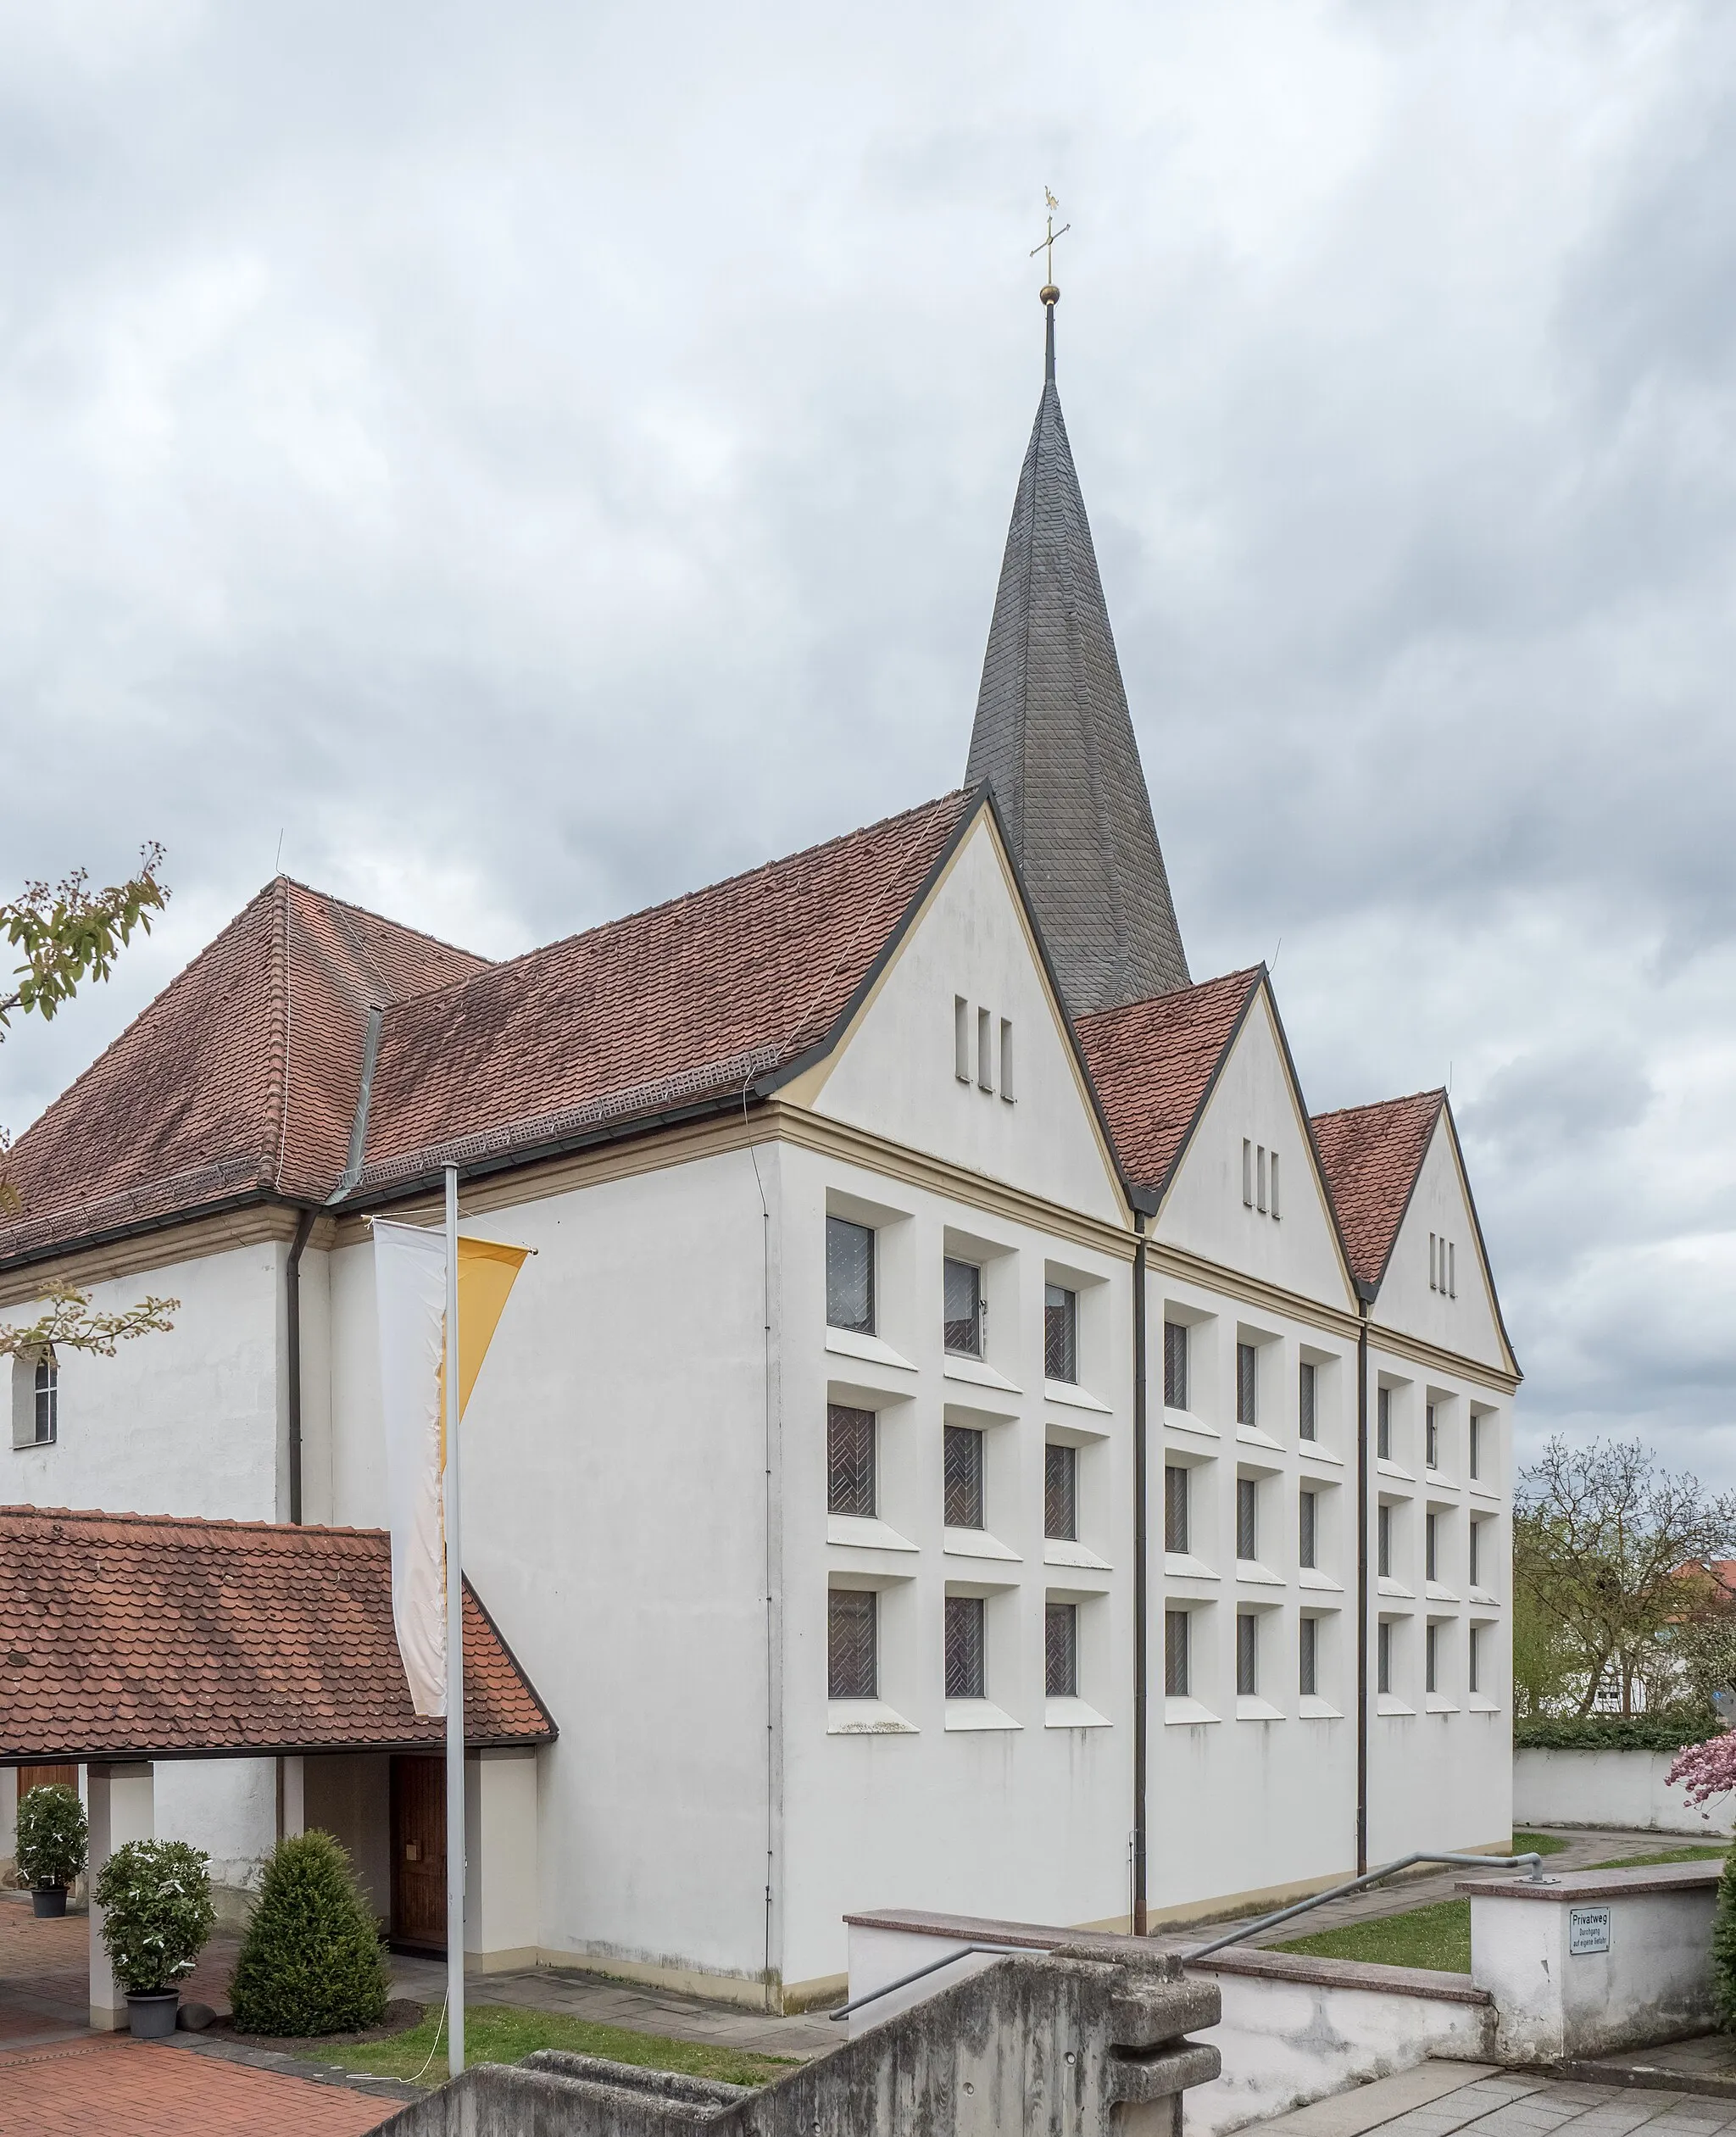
0, 1506, 554, 1763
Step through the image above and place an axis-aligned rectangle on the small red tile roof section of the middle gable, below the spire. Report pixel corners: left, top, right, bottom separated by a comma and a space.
1077, 964, 1266, 1194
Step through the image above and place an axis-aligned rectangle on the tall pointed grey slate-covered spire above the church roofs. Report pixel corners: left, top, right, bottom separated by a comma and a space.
964, 287, 1188, 1015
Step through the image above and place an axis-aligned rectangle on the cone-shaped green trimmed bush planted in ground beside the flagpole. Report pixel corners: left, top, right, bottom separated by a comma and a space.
229, 1831, 392, 2039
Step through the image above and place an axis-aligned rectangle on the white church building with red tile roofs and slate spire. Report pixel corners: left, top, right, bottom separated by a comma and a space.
0, 288, 1518, 2009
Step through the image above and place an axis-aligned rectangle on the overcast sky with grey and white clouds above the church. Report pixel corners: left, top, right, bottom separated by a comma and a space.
0, 0, 1736, 1483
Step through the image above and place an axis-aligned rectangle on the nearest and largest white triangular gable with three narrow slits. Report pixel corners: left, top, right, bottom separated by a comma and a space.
785, 795, 1127, 1227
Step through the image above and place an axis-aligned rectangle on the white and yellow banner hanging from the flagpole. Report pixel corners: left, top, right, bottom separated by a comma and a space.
374, 1222, 530, 1714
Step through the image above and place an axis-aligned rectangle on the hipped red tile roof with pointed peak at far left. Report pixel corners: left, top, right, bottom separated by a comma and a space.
0, 877, 487, 1259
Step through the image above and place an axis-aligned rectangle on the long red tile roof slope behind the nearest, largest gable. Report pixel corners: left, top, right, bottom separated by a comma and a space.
350, 793, 979, 1194
